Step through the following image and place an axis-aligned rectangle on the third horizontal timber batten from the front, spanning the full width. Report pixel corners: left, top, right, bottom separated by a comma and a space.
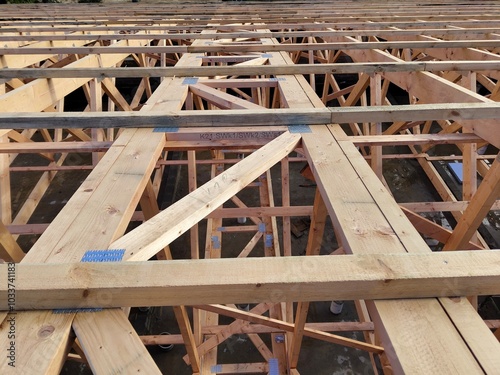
0, 61, 498, 79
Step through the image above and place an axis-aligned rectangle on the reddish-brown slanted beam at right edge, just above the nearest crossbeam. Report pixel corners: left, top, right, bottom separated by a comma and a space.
443, 153, 500, 250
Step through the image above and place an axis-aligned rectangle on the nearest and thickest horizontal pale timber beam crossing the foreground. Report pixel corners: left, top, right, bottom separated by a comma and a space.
0, 250, 500, 310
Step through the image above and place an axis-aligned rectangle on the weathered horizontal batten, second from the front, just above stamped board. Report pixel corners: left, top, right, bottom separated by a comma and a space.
0, 102, 500, 131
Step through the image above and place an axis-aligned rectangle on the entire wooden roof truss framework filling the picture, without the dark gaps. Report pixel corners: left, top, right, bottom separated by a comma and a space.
0, 0, 500, 374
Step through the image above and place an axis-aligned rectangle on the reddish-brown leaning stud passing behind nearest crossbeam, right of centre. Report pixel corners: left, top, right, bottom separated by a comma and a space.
289, 189, 328, 369
